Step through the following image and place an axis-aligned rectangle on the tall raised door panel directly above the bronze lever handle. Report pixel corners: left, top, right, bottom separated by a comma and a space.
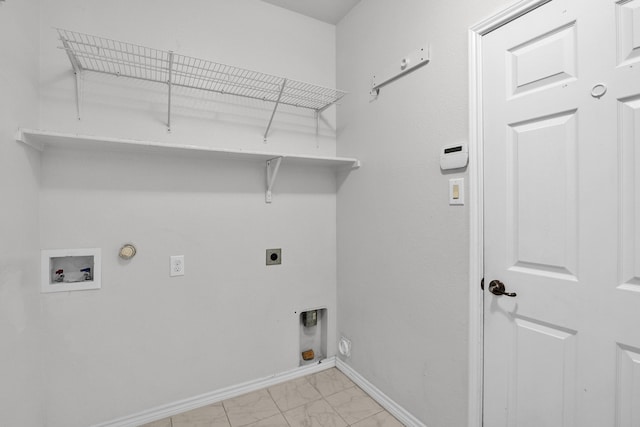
506, 110, 577, 280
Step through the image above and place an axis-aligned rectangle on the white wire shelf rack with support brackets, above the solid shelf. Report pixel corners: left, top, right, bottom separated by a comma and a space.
56, 28, 346, 141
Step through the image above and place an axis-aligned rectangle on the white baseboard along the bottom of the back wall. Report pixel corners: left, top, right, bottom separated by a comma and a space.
93, 356, 336, 427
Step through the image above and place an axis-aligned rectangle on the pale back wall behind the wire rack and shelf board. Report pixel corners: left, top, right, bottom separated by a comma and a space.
34, 0, 336, 427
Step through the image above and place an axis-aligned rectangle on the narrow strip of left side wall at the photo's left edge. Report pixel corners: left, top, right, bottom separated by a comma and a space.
0, 0, 44, 427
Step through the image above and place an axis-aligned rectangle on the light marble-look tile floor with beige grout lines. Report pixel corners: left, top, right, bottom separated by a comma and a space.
142, 368, 402, 427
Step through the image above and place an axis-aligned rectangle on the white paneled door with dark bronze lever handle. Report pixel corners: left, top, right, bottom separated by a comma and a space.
482, 0, 640, 427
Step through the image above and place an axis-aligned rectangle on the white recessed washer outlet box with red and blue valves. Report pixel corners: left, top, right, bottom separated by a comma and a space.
40, 248, 102, 293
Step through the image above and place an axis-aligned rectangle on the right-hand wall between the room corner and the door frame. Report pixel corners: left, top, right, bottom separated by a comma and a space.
337, 0, 507, 427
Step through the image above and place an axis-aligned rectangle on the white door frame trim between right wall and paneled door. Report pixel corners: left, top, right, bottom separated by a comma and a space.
468, 0, 552, 427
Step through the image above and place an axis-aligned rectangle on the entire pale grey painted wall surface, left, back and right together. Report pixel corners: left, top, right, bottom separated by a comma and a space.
0, 0, 528, 427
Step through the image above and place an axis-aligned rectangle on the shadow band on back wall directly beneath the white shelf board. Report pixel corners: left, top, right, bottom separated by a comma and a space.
42, 145, 336, 197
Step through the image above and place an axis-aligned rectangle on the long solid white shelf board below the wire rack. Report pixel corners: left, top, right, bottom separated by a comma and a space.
16, 129, 360, 168
